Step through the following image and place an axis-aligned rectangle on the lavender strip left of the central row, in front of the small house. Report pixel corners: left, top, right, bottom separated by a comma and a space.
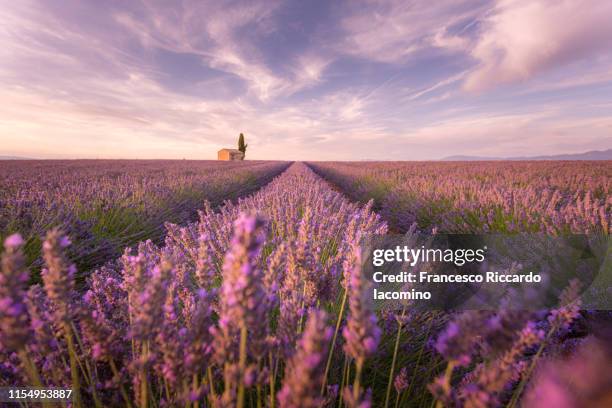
0, 160, 288, 270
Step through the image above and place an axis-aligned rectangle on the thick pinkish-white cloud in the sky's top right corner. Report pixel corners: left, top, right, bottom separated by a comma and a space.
464, 0, 612, 91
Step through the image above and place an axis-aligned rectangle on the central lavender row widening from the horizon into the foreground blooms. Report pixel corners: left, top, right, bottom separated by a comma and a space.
0, 163, 611, 408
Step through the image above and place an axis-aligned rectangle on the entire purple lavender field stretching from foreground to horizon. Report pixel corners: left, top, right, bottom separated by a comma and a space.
0, 162, 612, 408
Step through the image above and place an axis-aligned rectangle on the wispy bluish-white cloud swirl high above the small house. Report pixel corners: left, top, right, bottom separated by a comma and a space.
115, 0, 330, 102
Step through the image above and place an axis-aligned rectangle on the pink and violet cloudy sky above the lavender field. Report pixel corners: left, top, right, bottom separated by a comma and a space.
0, 0, 612, 160
